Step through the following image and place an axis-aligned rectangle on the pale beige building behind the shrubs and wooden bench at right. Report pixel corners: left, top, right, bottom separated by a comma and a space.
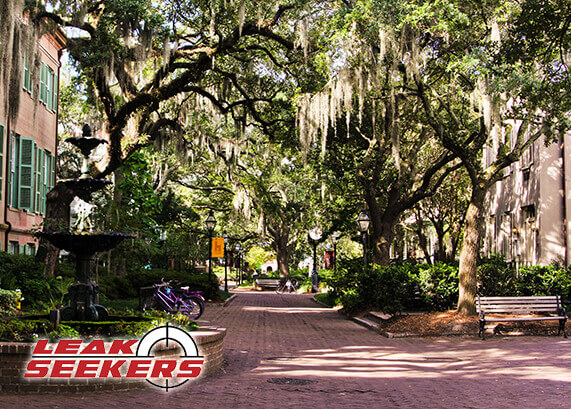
482, 134, 571, 265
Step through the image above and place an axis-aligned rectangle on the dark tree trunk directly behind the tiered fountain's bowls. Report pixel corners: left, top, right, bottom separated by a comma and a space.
36, 183, 74, 275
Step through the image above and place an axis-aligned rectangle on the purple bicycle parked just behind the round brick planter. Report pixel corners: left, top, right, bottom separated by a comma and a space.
144, 280, 204, 319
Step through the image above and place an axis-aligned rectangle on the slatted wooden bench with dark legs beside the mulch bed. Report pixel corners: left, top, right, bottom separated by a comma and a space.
476, 295, 567, 339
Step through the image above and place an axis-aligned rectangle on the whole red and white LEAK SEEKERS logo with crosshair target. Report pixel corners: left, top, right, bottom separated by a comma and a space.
24, 325, 204, 391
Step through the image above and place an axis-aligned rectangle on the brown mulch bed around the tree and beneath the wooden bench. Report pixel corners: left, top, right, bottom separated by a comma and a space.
379, 310, 571, 337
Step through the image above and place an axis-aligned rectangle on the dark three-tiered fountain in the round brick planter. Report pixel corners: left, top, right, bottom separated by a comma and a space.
38, 124, 132, 321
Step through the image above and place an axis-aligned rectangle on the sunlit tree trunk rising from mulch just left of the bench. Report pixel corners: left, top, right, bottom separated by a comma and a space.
458, 183, 486, 315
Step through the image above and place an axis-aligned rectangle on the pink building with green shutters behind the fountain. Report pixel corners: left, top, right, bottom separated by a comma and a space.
0, 26, 65, 254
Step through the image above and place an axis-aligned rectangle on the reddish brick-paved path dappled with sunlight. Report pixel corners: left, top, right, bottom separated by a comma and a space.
0, 292, 571, 409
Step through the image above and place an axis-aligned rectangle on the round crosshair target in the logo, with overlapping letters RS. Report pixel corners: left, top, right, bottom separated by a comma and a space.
136, 323, 204, 391
